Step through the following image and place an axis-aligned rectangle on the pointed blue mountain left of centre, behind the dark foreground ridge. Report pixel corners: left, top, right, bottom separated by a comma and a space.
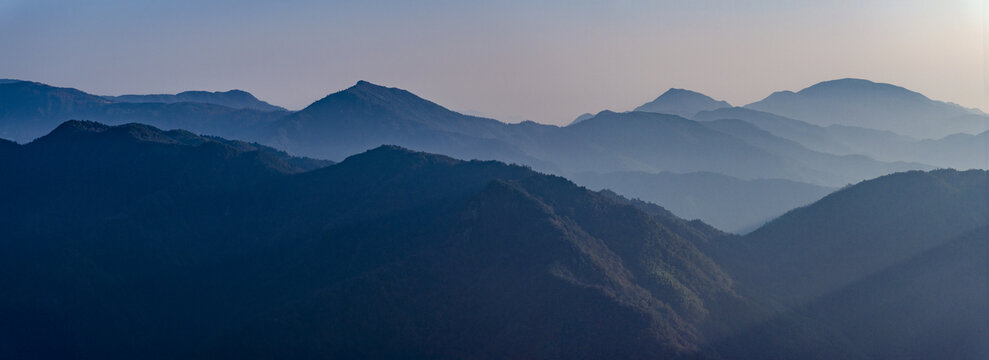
262, 81, 539, 164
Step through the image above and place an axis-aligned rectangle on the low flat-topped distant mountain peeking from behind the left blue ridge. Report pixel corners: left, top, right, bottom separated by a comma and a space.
103, 90, 287, 111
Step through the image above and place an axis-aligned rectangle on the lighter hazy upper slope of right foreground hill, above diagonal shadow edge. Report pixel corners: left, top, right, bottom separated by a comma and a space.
716, 170, 989, 305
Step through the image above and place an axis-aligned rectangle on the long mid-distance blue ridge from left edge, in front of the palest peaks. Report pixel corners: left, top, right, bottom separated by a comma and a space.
0, 81, 956, 230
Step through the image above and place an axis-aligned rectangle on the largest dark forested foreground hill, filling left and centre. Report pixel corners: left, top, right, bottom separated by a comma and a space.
0, 122, 855, 358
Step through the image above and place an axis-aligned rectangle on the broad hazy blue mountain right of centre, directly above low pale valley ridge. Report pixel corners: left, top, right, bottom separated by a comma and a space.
519, 111, 831, 181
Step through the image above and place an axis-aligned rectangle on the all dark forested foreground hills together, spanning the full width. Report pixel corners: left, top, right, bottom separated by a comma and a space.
0, 121, 989, 359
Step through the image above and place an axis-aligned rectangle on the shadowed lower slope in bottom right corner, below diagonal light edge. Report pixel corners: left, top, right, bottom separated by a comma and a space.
804, 227, 989, 360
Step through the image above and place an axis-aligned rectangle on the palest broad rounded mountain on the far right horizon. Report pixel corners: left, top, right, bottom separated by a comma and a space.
745, 79, 989, 139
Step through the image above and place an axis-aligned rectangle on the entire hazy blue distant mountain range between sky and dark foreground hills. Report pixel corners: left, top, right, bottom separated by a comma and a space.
0, 77, 989, 232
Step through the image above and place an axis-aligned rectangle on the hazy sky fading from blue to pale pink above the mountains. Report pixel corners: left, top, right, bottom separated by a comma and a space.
0, 0, 989, 124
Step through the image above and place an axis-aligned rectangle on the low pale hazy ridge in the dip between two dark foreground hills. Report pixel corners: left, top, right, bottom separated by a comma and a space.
571, 172, 835, 233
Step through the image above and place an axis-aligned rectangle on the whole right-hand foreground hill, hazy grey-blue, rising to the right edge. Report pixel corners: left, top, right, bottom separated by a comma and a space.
708, 170, 989, 359
